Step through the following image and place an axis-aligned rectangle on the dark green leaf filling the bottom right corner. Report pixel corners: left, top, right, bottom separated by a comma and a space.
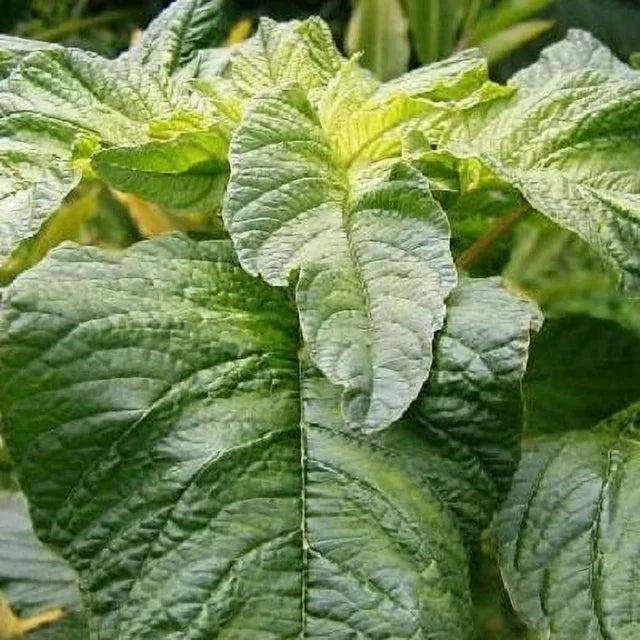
498, 403, 640, 640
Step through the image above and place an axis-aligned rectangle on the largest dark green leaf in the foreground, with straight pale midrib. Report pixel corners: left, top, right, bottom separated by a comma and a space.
0, 236, 498, 640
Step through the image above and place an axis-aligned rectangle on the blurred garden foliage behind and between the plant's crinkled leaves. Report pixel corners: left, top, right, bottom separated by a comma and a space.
0, 0, 640, 640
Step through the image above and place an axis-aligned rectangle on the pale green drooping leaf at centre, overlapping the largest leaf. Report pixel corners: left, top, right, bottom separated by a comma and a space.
223, 88, 456, 431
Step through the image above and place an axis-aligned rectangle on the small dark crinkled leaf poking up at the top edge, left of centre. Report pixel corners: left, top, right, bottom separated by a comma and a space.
125, 0, 230, 73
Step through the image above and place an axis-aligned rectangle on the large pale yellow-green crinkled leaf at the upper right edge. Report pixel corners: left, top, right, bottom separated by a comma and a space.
440, 31, 640, 288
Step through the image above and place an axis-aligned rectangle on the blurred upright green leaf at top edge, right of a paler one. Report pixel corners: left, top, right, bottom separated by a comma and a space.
406, 0, 468, 63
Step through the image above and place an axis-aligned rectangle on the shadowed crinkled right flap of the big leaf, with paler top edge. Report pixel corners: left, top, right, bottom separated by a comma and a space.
404, 278, 542, 542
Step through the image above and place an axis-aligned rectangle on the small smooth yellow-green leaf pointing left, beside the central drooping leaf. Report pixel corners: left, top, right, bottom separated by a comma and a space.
92, 130, 229, 211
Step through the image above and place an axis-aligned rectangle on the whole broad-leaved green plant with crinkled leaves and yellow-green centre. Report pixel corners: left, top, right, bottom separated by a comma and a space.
0, 0, 640, 640
